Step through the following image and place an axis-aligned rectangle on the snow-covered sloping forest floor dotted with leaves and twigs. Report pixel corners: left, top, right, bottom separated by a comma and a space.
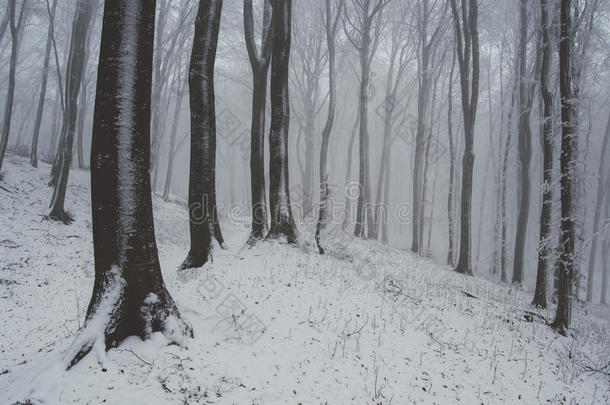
0, 156, 610, 405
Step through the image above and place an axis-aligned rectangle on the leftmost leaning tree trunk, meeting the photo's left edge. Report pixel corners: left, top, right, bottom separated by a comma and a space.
0, 0, 27, 171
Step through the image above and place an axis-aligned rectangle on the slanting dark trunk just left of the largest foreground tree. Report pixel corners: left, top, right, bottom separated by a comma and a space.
49, 0, 94, 224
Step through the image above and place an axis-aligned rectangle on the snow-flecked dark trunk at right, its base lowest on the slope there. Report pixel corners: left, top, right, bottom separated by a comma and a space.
552, 0, 578, 334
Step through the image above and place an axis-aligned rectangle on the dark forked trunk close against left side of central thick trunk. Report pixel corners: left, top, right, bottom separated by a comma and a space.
244, 0, 273, 244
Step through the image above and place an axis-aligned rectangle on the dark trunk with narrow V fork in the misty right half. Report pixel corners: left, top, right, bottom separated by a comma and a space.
451, 0, 479, 274
